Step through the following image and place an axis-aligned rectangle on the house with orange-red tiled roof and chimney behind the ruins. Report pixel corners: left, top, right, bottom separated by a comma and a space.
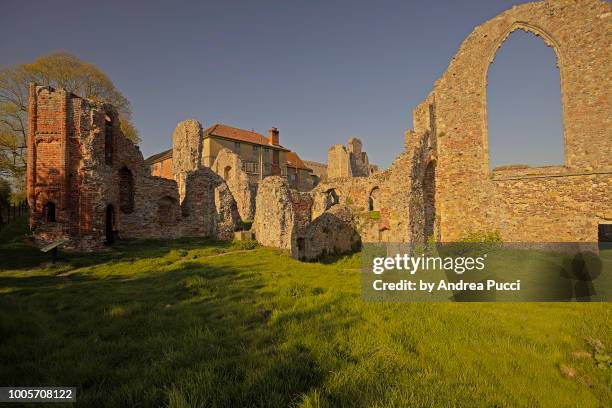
146, 123, 312, 190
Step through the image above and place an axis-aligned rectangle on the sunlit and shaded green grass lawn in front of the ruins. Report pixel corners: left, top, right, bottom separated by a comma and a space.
0, 225, 612, 407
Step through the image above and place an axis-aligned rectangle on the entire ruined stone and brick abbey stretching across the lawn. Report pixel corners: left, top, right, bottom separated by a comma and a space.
27, 0, 612, 260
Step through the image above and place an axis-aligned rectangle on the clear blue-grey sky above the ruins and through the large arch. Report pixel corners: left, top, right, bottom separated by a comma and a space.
0, 0, 563, 167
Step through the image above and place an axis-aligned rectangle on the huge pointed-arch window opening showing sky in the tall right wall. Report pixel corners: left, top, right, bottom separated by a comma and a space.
486, 30, 565, 169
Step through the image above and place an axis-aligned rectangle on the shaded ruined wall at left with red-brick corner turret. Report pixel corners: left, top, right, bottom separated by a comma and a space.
27, 85, 239, 249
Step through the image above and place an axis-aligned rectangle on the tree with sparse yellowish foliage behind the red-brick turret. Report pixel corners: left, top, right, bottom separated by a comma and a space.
0, 52, 140, 186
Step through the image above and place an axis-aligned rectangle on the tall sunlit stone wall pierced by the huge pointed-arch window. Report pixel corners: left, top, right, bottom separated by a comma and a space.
406, 0, 612, 242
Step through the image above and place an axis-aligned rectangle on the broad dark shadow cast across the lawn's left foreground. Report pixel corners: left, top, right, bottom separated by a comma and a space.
0, 253, 323, 407
